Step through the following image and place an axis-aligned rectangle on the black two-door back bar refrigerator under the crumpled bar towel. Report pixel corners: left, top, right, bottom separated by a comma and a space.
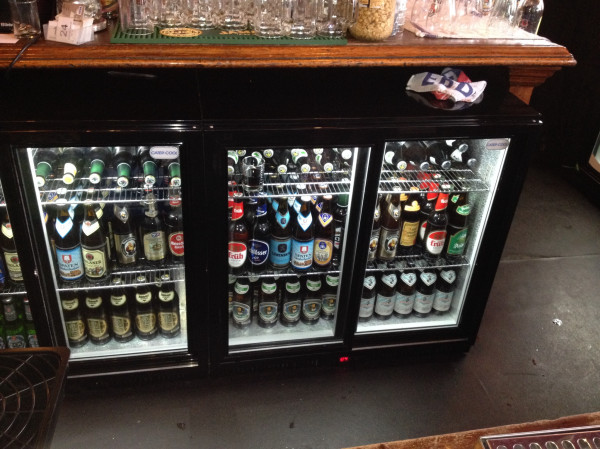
202, 65, 541, 370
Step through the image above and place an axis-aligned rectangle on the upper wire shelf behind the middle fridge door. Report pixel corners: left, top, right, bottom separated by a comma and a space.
228, 171, 351, 198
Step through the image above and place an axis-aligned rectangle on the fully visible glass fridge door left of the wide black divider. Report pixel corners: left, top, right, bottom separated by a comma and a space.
26, 145, 188, 360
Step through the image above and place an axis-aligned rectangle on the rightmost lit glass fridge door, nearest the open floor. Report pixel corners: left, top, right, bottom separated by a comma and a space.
356, 139, 510, 335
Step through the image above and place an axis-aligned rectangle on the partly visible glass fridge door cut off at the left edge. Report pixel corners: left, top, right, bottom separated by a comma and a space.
0, 180, 39, 349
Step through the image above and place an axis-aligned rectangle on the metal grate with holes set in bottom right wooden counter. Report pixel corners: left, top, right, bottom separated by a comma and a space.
481, 426, 600, 449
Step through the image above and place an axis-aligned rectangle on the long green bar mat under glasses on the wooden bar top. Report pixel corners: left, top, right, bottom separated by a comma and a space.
110, 24, 348, 45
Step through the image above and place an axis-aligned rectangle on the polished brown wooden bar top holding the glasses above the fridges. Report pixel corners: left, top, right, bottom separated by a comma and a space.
0, 27, 576, 103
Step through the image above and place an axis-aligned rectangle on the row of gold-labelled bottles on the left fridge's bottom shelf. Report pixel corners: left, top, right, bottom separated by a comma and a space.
60, 273, 181, 347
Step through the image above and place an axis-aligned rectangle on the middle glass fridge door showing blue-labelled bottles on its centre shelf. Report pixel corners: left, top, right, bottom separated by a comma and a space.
227, 147, 365, 350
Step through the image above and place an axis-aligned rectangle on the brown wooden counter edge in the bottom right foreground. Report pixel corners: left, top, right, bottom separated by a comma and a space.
347, 412, 600, 449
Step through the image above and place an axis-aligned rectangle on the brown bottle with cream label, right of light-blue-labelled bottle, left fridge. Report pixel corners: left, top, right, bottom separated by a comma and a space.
79, 204, 109, 282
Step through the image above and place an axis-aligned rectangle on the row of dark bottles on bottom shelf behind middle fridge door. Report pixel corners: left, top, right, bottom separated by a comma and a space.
229, 274, 339, 328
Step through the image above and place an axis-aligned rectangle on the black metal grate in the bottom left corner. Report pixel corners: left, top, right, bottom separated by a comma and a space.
0, 348, 69, 449
